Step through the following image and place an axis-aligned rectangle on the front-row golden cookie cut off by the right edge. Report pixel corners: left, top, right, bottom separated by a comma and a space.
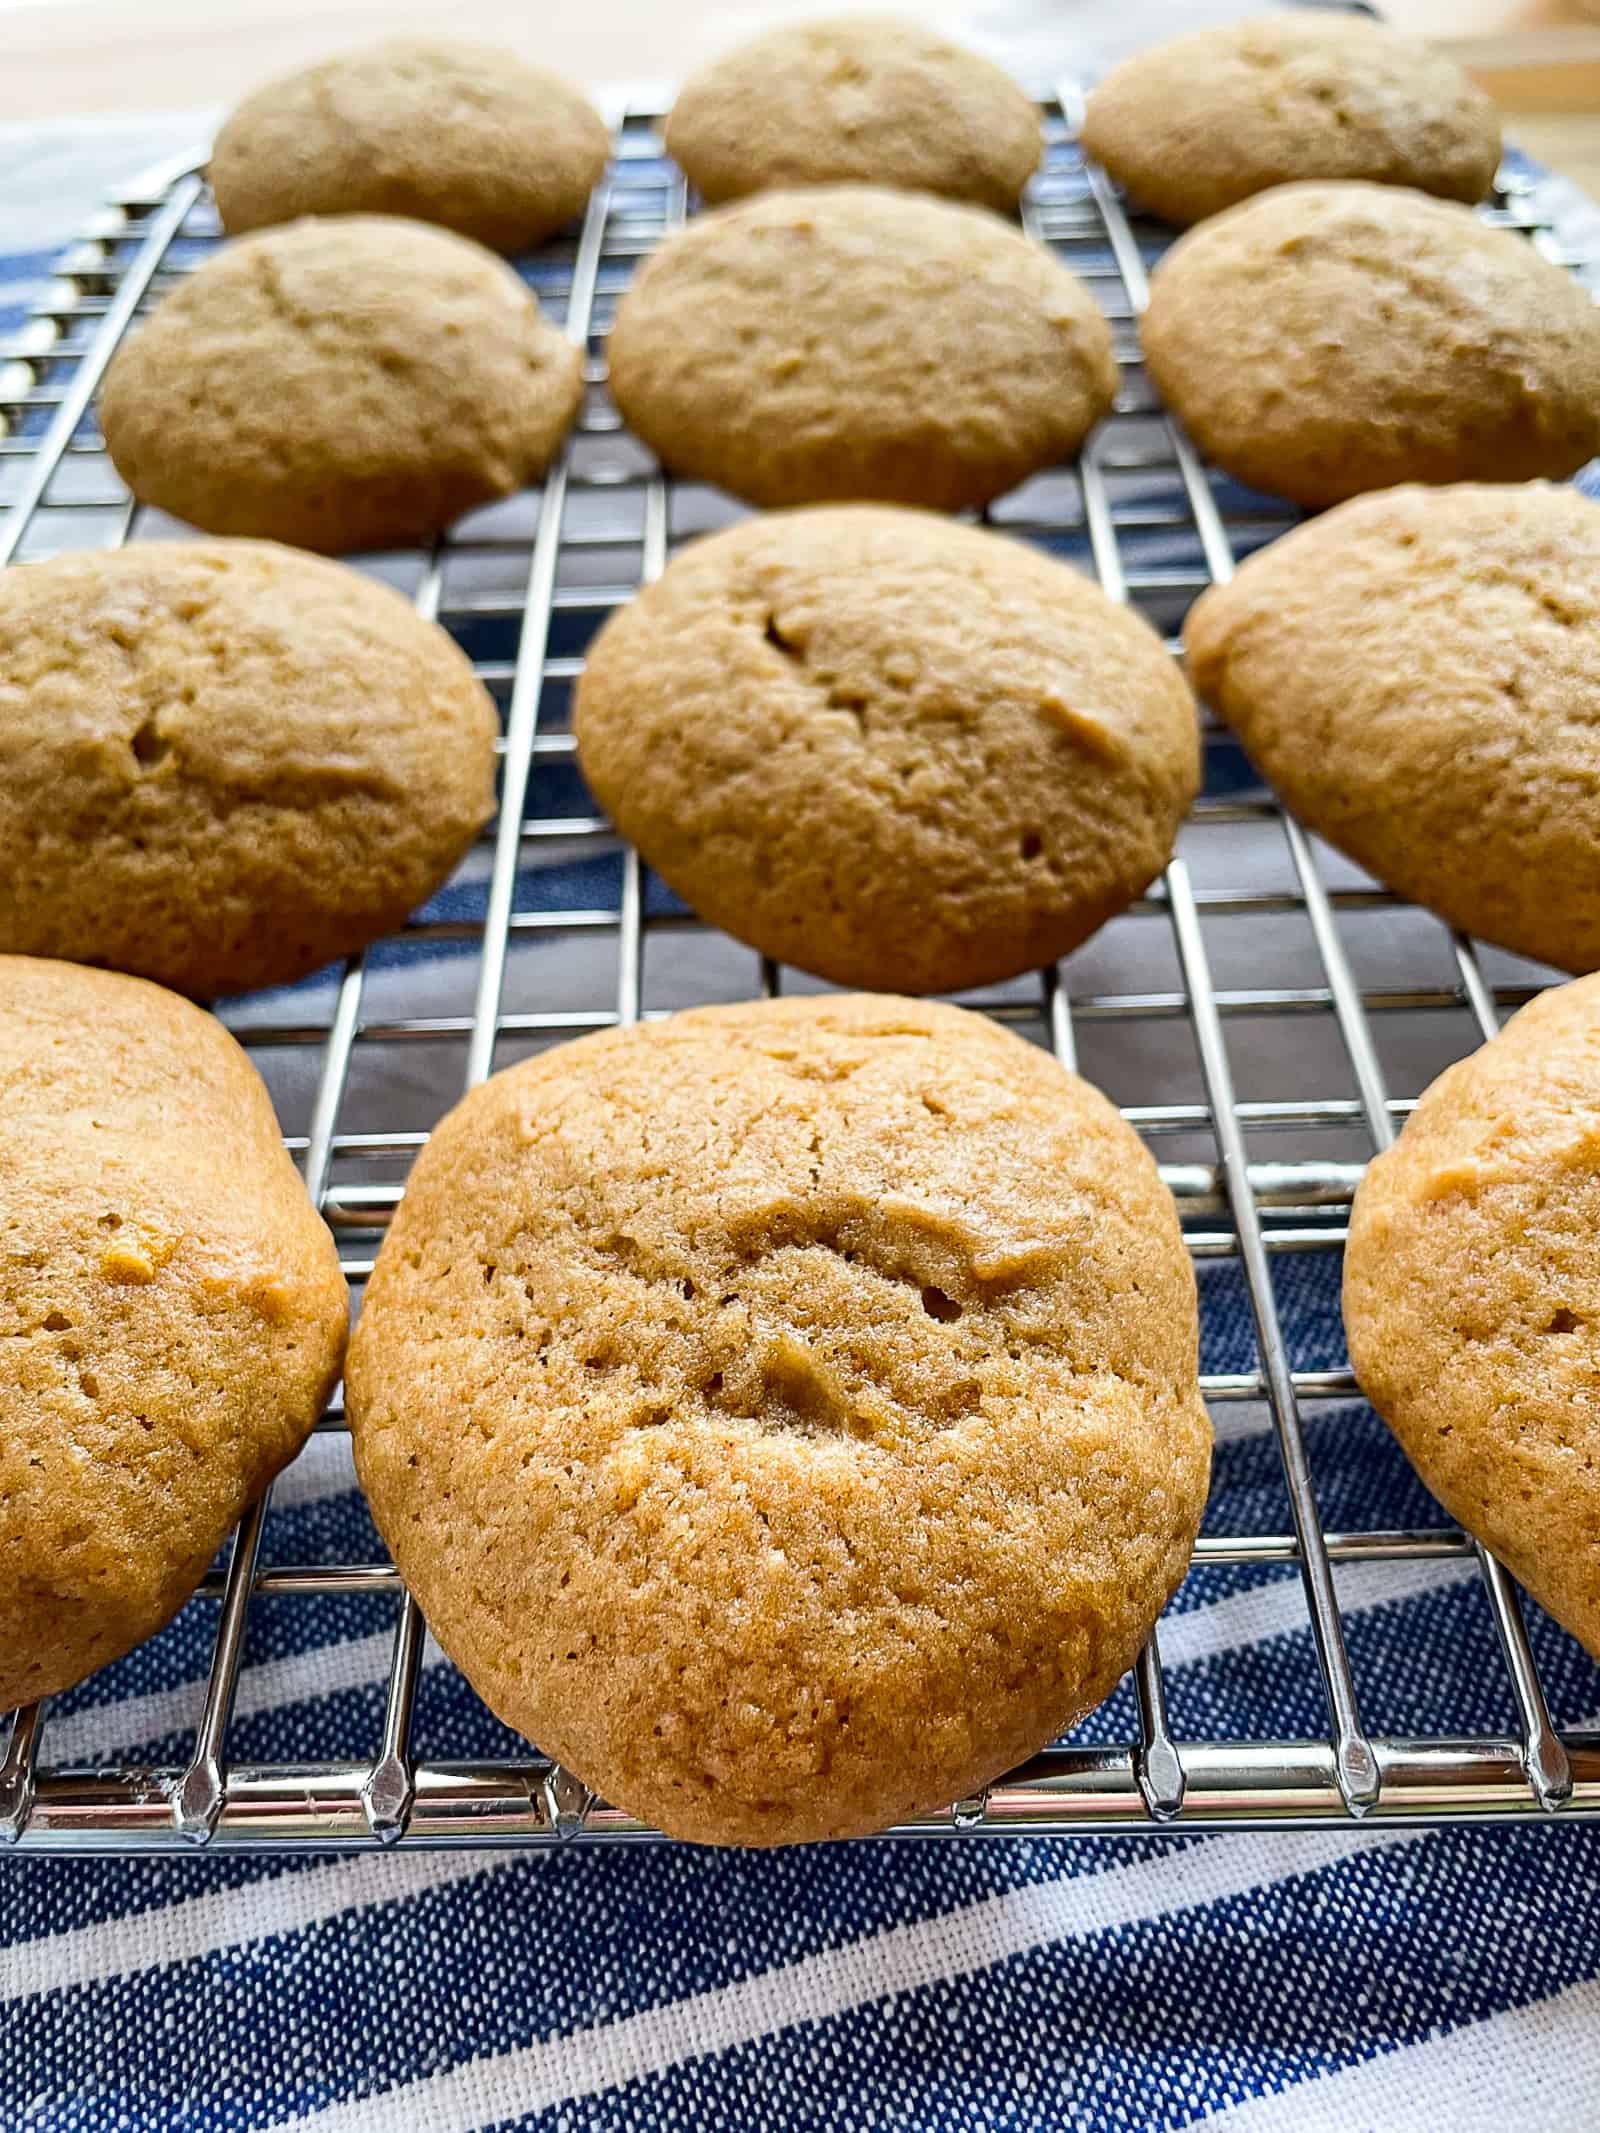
1344, 977, 1600, 1659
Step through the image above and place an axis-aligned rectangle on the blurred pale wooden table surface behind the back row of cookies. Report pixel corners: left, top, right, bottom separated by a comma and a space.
0, 0, 1600, 194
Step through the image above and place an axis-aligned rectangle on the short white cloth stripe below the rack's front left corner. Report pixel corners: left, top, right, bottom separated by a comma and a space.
0, 1851, 529, 2001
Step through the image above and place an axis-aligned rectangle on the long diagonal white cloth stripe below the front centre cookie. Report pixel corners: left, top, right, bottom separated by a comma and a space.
257, 1830, 1425, 2133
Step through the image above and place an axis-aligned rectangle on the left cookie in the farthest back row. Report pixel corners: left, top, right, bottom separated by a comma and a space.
209, 36, 610, 252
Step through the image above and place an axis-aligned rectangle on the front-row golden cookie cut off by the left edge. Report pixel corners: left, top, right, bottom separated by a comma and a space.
0, 956, 346, 1711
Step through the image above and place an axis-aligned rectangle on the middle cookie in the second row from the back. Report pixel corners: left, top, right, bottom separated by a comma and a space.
610, 186, 1116, 510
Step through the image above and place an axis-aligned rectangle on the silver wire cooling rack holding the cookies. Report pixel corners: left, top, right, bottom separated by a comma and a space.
0, 92, 1600, 1851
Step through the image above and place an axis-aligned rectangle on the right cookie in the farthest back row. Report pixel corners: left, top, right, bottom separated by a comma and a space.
1082, 9, 1500, 224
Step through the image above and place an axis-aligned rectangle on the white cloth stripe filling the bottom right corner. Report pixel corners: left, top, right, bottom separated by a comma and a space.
1205, 1979, 1600, 2133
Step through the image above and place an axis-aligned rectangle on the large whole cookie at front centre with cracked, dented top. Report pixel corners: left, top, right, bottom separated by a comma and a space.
348, 996, 1210, 1845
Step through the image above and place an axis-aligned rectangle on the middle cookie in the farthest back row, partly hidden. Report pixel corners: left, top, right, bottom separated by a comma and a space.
666, 15, 1039, 213
